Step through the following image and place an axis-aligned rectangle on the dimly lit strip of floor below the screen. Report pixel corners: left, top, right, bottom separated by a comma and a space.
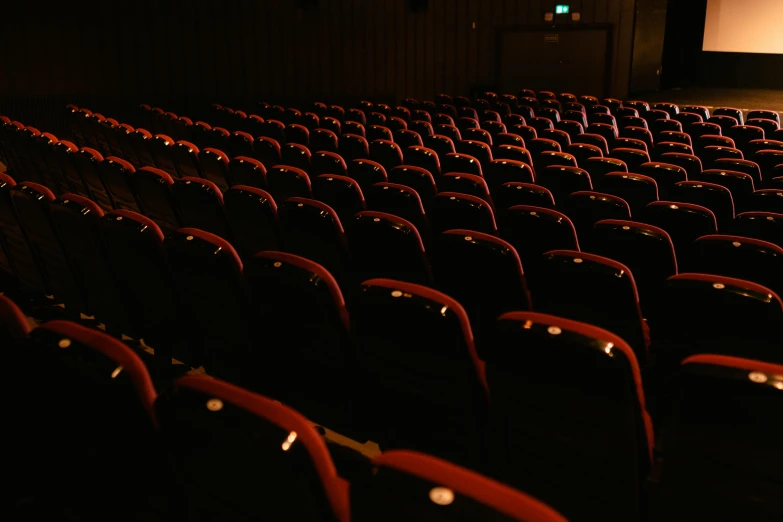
631, 87, 783, 115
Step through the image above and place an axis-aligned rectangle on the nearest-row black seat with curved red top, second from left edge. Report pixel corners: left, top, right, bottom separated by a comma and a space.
16, 321, 160, 520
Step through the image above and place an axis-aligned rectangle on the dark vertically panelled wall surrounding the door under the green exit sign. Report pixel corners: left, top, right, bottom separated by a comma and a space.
0, 0, 635, 120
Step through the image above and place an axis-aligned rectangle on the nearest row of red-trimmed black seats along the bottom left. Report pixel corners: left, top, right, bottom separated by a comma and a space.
0, 296, 576, 522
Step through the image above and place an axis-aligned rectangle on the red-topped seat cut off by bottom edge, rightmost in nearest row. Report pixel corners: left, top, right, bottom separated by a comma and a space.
351, 450, 565, 522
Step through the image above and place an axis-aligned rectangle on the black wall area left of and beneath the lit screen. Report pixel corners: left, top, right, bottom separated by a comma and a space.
662, 0, 783, 89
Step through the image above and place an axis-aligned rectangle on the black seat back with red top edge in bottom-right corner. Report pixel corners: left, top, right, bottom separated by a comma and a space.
661, 353, 783, 521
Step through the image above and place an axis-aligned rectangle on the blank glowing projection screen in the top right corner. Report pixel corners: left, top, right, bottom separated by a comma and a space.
704, 0, 783, 54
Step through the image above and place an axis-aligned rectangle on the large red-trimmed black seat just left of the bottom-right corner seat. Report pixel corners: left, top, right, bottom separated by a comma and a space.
480, 312, 654, 522
